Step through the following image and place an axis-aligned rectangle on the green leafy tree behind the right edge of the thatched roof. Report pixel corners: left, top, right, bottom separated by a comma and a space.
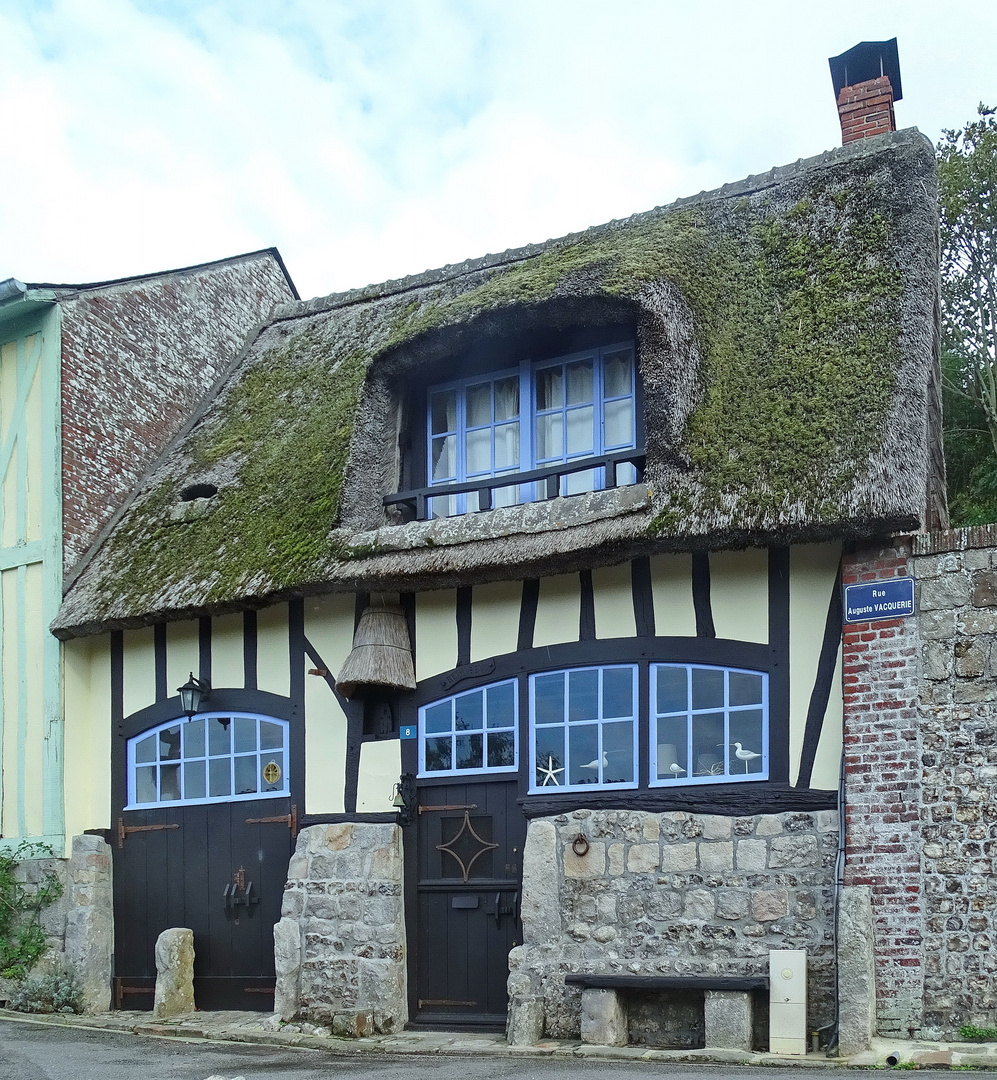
938, 104, 997, 525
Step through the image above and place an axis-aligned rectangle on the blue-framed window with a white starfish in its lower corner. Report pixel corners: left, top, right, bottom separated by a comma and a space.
529, 664, 638, 792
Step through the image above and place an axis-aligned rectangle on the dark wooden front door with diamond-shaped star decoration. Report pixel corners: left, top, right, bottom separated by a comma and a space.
408, 779, 526, 1030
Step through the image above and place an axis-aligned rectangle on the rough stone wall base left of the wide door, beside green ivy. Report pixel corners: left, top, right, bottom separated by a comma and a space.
0, 836, 114, 1013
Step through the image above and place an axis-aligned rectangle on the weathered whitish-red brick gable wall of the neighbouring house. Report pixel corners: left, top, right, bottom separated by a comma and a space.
60, 252, 293, 571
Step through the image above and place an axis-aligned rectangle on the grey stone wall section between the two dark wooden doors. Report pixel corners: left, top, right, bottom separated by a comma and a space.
274, 823, 408, 1037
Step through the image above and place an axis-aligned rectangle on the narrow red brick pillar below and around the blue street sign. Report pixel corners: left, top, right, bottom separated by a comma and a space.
843, 538, 924, 1038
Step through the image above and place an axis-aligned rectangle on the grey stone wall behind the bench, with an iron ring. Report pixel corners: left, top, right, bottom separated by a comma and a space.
509, 810, 838, 1042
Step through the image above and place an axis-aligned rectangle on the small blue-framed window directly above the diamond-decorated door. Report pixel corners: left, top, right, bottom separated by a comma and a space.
419, 679, 520, 777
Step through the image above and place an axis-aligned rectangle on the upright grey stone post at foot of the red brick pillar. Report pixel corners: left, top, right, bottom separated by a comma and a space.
838, 885, 876, 1057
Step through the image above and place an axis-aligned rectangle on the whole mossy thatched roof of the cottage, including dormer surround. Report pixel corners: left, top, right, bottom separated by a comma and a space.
54, 130, 938, 637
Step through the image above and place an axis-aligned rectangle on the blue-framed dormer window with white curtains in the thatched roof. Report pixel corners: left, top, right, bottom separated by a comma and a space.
427, 343, 636, 517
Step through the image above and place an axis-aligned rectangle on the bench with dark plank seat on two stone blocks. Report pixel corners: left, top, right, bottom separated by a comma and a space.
565, 974, 769, 1050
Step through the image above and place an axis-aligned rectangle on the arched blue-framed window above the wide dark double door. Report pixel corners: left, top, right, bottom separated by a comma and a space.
125, 713, 291, 810
